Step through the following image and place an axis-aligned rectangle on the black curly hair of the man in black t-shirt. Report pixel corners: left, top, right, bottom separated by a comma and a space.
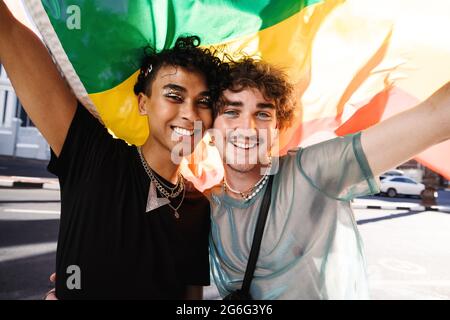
134, 36, 229, 104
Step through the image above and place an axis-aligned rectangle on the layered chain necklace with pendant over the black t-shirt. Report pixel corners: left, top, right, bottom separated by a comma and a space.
137, 147, 186, 219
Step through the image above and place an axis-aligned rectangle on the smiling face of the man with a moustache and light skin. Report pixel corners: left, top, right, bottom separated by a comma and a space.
214, 88, 277, 172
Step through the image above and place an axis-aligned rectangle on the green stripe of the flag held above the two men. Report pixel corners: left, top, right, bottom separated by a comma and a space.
42, 0, 321, 93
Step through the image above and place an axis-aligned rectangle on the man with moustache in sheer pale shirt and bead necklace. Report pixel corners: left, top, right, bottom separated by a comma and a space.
210, 59, 450, 299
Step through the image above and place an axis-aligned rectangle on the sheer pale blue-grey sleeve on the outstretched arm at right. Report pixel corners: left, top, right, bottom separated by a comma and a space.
297, 132, 380, 201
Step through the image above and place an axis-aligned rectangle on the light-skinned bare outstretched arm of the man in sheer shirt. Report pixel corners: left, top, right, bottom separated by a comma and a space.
361, 82, 450, 176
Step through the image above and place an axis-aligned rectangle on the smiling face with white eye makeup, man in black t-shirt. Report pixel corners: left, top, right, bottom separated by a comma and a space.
138, 66, 212, 156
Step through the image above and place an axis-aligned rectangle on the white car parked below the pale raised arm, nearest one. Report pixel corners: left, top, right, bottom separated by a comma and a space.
380, 176, 425, 198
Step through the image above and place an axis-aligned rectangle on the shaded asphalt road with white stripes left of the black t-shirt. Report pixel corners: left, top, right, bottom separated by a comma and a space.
0, 189, 60, 299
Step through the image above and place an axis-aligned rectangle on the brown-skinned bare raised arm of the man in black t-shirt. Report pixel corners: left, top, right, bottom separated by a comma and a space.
0, 0, 76, 155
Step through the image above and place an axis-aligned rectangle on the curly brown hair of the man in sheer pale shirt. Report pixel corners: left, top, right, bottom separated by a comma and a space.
215, 57, 295, 130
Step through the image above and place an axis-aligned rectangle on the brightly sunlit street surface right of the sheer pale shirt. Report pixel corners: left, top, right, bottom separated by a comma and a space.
355, 206, 450, 299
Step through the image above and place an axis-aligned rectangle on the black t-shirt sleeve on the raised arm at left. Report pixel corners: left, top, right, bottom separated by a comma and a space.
47, 102, 117, 184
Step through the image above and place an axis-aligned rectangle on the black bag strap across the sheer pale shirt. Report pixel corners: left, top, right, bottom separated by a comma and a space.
240, 175, 273, 294
